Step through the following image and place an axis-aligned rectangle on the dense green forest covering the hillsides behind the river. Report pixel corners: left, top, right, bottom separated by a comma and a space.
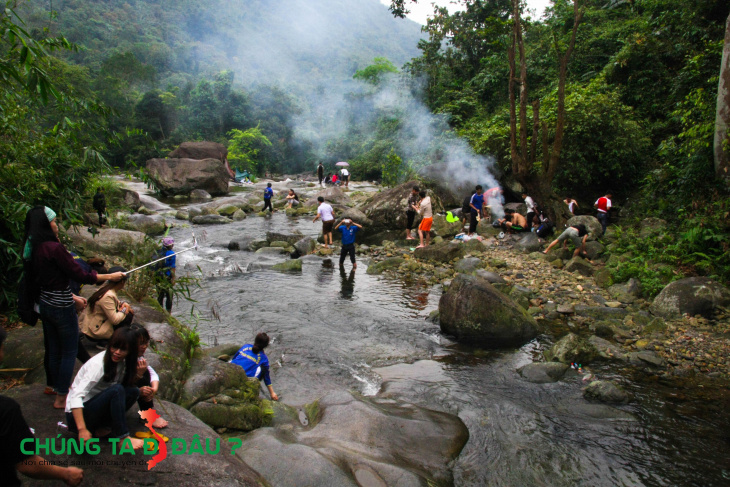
0, 0, 730, 304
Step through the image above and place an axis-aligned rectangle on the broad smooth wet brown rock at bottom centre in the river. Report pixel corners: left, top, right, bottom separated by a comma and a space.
239, 392, 469, 487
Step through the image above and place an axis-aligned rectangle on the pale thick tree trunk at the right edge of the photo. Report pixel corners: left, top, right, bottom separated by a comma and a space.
714, 15, 730, 185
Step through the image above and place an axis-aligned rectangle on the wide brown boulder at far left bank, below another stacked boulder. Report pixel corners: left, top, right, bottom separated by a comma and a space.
147, 158, 230, 196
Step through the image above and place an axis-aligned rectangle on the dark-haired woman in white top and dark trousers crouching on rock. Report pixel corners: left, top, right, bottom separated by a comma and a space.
66, 326, 143, 450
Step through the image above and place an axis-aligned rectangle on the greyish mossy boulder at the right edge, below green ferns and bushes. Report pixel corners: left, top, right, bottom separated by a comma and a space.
651, 277, 730, 318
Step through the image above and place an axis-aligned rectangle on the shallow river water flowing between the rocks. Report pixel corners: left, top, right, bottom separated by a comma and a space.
155, 193, 730, 486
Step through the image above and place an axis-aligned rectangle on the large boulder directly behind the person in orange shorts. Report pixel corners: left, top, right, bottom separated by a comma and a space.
363, 181, 443, 230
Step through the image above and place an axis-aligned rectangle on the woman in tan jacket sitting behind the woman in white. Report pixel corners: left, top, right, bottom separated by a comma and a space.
79, 267, 134, 349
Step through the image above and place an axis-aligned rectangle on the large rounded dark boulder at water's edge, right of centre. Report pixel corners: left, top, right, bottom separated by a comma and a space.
439, 274, 538, 347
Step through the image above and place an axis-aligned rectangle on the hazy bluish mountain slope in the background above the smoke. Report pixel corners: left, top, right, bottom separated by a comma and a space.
21, 0, 422, 87
